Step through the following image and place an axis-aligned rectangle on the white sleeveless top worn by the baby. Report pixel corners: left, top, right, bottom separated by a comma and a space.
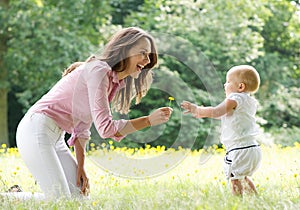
221, 93, 259, 150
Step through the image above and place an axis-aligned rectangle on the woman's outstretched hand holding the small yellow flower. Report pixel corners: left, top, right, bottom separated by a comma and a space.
148, 107, 173, 126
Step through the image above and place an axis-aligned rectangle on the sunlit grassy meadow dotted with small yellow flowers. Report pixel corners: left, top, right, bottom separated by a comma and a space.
0, 143, 300, 210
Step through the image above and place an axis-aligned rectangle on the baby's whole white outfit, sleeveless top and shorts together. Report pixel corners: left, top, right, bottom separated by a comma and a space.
221, 93, 262, 179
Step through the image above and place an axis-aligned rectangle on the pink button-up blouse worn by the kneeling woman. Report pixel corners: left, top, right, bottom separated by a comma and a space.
29, 60, 127, 146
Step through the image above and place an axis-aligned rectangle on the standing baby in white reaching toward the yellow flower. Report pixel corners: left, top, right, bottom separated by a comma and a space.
181, 65, 262, 195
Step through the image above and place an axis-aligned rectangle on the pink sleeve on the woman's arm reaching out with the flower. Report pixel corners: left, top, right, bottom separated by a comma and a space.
86, 66, 127, 141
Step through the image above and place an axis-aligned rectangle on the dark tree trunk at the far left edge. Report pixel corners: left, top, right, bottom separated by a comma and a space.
0, 0, 9, 147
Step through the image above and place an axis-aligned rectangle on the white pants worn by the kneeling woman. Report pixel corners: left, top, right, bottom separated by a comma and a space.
16, 113, 80, 198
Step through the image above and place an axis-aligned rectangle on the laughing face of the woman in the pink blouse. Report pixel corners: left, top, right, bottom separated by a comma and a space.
124, 37, 151, 79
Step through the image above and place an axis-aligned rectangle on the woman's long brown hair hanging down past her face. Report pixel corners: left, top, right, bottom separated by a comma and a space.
63, 27, 157, 114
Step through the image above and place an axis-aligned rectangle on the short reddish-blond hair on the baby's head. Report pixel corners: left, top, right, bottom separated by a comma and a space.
227, 65, 260, 93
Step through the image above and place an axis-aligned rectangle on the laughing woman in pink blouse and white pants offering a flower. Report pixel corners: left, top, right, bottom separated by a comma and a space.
17, 27, 172, 198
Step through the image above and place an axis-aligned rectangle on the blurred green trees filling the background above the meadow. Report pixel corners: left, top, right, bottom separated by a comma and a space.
0, 0, 300, 149
